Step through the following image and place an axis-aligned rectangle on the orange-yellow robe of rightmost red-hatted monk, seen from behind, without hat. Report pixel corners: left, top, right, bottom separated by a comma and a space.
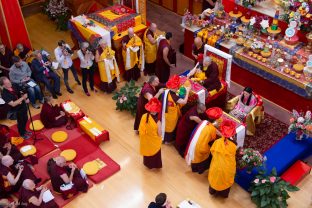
208, 137, 236, 191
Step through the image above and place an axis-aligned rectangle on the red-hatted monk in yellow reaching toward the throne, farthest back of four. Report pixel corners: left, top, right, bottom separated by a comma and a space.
161, 75, 191, 143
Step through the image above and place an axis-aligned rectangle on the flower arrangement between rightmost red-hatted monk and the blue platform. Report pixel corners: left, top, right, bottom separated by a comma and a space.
238, 148, 266, 172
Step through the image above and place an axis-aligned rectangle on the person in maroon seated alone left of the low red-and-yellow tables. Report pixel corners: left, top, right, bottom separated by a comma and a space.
40, 96, 67, 128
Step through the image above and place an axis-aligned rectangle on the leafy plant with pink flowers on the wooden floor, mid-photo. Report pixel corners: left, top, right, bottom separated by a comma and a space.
112, 80, 141, 116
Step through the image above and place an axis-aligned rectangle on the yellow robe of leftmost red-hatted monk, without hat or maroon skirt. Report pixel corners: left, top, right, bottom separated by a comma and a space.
139, 113, 162, 156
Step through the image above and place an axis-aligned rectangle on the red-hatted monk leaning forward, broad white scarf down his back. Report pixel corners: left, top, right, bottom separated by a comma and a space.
185, 108, 223, 174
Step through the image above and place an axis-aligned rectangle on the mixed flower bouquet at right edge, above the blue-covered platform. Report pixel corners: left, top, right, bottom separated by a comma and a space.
288, 110, 312, 140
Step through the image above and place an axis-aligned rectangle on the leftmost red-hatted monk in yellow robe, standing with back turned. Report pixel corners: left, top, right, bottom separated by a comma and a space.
139, 97, 162, 169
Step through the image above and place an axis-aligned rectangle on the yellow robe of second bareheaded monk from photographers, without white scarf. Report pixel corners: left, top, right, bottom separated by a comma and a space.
122, 35, 143, 70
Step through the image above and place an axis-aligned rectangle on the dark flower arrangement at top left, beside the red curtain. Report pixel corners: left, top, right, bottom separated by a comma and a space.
43, 0, 71, 30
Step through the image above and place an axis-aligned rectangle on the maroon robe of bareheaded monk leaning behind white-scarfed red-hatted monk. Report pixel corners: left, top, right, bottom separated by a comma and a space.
175, 106, 203, 157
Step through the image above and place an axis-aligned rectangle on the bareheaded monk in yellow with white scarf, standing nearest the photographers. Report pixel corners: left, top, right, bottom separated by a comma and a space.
95, 39, 120, 93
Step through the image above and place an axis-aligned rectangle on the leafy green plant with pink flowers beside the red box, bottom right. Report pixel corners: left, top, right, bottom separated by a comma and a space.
250, 168, 299, 208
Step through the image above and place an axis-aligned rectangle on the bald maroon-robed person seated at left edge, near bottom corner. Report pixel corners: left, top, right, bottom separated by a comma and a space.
0, 155, 41, 194
